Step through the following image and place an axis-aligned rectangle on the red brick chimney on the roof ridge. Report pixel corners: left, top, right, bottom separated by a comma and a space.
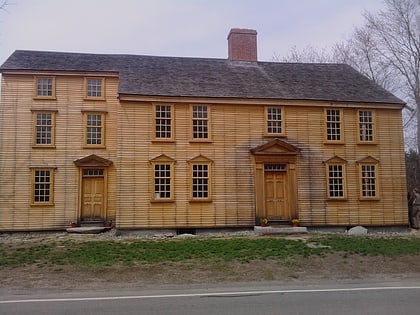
228, 28, 257, 62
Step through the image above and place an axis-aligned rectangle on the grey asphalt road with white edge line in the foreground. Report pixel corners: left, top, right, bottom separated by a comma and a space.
0, 280, 420, 315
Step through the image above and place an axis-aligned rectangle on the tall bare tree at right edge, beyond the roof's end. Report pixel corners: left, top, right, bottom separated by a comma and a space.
359, 0, 420, 152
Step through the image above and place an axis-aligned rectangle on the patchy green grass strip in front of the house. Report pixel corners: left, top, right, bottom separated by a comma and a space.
0, 235, 420, 269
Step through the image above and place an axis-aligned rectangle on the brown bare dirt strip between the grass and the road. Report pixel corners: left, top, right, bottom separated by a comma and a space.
0, 254, 420, 289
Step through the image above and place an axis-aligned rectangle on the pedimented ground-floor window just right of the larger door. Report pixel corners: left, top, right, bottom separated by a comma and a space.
325, 156, 347, 199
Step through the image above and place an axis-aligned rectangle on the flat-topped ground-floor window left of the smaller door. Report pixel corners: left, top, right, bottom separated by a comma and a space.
32, 168, 54, 205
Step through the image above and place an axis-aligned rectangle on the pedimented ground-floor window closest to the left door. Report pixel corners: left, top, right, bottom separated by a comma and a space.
151, 154, 175, 202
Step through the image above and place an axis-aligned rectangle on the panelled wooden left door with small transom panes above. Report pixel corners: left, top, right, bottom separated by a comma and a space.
81, 169, 105, 221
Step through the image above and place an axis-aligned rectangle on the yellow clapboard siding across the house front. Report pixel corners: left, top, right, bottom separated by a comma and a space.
0, 74, 407, 230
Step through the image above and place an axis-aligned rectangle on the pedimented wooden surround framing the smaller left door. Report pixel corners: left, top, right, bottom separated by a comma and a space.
74, 154, 112, 221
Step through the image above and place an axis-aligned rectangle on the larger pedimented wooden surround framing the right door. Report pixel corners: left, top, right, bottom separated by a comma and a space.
251, 139, 300, 220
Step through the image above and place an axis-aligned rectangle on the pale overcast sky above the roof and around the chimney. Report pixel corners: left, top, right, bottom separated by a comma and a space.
0, 0, 384, 64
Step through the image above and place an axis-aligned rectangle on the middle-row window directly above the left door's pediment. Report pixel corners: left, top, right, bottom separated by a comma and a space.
83, 112, 105, 148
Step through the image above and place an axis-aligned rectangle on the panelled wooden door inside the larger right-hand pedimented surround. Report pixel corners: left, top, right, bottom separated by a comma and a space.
264, 172, 290, 220
